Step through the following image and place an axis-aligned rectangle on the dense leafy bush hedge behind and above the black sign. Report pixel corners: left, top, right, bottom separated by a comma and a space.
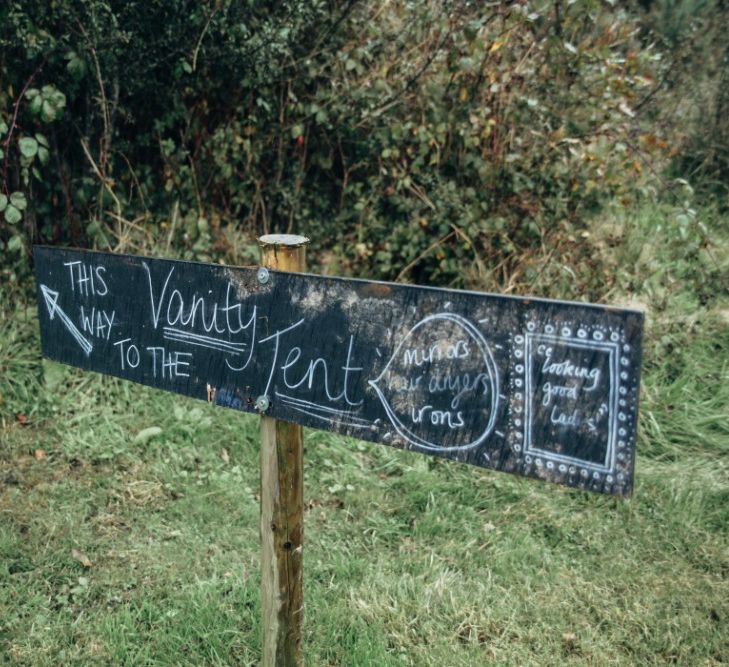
0, 0, 668, 289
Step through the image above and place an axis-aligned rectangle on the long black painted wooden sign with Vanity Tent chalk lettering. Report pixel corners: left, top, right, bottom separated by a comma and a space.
35, 247, 643, 495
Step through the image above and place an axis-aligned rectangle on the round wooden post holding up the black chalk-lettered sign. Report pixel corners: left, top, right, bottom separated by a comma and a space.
258, 234, 309, 667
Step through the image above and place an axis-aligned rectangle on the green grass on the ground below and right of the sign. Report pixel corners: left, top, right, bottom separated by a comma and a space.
0, 206, 729, 667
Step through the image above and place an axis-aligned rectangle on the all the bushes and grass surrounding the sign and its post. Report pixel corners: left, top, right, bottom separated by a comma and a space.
0, 0, 729, 665
